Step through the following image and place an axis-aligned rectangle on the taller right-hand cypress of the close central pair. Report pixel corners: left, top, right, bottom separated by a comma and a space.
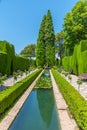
45, 10, 55, 66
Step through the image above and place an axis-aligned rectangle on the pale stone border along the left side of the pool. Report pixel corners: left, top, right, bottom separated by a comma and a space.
0, 70, 44, 130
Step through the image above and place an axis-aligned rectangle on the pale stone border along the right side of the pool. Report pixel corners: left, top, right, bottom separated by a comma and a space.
50, 71, 79, 130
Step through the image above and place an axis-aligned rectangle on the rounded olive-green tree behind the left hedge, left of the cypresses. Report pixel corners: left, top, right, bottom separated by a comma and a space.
20, 44, 36, 58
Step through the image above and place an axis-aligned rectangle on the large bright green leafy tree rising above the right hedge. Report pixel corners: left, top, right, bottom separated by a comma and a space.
63, 1, 87, 55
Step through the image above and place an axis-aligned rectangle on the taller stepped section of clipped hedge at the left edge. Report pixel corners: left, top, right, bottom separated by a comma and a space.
0, 41, 15, 75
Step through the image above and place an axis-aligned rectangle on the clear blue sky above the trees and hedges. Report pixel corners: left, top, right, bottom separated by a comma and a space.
0, 0, 78, 53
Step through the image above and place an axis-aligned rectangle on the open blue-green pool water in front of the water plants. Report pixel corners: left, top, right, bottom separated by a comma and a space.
9, 89, 60, 130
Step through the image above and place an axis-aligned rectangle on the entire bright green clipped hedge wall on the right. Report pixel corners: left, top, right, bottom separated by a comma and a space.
62, 40, 87, 75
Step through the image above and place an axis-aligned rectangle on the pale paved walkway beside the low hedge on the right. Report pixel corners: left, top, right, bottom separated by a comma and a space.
61, 74, 87, 100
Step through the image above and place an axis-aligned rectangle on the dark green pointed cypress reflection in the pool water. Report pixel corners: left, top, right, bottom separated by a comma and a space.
37, 89, 54, 127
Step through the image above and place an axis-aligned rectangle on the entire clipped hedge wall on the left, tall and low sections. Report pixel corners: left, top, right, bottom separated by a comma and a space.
0, 41, 29, 75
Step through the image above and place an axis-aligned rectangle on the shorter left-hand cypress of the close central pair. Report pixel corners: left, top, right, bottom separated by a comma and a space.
36, 16, 46, 67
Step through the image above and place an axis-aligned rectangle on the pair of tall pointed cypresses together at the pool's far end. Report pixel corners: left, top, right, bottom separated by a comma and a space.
36, 10, 55, 66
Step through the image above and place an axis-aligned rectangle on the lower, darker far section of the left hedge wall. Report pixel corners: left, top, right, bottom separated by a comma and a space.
14, 55, 29, 71
